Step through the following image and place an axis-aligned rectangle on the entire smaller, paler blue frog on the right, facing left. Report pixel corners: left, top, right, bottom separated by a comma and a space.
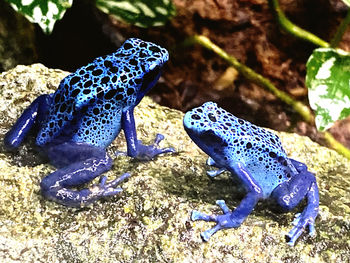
183, 102, 319, 246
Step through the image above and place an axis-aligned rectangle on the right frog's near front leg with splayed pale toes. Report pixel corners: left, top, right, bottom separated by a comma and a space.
191, 163, 262, 241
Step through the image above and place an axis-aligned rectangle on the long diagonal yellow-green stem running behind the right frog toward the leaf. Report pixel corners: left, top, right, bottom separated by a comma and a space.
190, 35, 314, 124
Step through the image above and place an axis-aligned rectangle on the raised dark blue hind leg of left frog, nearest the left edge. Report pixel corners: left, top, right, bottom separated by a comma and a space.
4, 94, 52, 149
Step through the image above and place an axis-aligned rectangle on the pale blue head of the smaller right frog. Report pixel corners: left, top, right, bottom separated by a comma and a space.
183, 102, 230, 160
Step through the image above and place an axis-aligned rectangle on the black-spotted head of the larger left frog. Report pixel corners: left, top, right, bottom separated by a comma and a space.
116, 38, 169, 104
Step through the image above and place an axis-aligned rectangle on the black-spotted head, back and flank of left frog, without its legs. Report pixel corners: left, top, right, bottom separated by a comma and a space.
37, 39, 168, 147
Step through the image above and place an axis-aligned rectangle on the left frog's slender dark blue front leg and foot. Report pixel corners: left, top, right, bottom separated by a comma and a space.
122, 108, 175, 161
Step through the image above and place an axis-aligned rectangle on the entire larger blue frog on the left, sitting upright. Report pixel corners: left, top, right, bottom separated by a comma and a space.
4, 38, 174, 207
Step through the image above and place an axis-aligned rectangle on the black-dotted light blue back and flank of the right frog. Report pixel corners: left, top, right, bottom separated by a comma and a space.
213, 108, 294, 197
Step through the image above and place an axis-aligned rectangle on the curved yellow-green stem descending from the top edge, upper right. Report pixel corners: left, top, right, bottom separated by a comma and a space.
269, 0, 330, 47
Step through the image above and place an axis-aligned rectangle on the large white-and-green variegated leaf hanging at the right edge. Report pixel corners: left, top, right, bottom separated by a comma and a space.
306, 48, 350, 131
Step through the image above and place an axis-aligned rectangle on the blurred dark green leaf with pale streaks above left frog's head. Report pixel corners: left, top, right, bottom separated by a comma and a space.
96, 0, 175, 27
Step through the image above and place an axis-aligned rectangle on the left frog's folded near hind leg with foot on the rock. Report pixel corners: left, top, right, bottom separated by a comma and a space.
40, 142, 130, 207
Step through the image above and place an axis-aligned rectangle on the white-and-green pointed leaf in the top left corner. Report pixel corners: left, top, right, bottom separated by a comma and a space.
7, 0, 73, 34
